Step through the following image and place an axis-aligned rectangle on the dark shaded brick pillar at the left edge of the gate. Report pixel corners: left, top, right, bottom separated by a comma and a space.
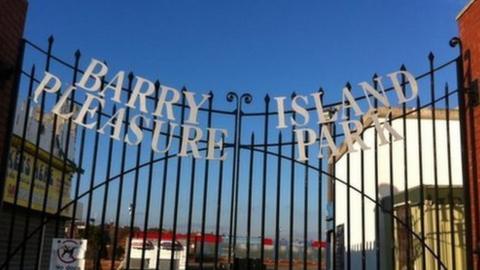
0, 0, 28, 200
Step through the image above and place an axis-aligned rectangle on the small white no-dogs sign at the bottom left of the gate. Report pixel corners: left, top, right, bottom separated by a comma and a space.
49, 238, 87, 270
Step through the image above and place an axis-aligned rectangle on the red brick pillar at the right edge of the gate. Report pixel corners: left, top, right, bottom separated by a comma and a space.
457, 0, 480, 269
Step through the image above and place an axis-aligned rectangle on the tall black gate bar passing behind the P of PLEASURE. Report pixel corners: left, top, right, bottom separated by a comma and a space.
20, 36, 54, 269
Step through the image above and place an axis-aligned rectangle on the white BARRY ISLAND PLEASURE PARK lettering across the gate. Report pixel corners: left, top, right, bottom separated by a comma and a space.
33, 59, 418, 162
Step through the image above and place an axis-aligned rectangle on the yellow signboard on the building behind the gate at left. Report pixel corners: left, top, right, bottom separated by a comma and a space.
3, 135, 74, 216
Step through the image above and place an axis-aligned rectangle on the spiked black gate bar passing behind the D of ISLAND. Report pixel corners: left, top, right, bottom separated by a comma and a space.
400, 65, 413, 269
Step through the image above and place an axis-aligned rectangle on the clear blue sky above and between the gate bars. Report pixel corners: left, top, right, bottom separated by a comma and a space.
21, 0, 466, 239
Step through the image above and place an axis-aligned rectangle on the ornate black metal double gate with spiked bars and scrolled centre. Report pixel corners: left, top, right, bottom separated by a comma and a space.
0, 38, 471, 270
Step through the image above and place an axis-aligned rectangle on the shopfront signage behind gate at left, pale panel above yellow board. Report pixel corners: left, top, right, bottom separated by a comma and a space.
3, 101, 75, 216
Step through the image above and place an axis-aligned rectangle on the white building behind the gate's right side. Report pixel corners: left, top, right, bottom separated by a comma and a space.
327, 108, 465, 269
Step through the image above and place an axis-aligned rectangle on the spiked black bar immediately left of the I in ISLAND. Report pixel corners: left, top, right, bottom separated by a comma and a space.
260, 95, 270, 264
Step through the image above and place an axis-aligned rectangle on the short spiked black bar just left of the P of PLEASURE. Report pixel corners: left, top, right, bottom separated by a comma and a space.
2, 62, 35, 269
